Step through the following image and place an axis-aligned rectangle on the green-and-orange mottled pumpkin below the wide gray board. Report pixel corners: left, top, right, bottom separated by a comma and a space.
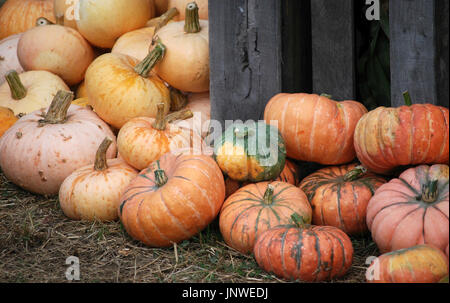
214, 122, 286, 182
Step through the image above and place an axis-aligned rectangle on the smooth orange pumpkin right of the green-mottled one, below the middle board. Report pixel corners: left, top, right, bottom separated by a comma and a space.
264, 94, 367, 165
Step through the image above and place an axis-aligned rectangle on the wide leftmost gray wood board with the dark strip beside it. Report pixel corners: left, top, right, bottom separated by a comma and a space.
209, 0, 311, 129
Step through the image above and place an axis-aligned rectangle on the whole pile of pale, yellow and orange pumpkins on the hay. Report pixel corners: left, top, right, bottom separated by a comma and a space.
0, 0, 449, 282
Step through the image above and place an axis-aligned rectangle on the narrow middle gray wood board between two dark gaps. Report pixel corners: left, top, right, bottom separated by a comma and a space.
311, 0, 356, 100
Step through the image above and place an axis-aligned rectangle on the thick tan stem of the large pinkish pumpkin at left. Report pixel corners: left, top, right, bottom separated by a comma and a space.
39, 90, 73, 127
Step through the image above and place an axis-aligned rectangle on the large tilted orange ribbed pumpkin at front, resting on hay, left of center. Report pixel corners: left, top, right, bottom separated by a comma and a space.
119, 153, 225, 247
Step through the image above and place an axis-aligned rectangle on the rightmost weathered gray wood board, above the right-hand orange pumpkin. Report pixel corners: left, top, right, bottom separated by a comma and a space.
389, 0, 449, 107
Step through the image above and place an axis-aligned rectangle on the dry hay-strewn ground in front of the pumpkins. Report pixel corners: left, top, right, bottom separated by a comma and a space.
0, 172, 378, 283
